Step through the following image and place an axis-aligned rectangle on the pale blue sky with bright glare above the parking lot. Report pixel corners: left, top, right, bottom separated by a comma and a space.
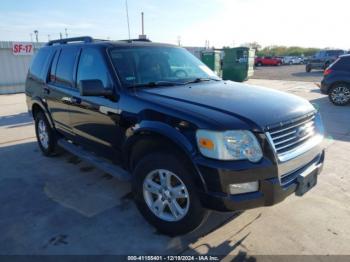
0, 0, 350, 49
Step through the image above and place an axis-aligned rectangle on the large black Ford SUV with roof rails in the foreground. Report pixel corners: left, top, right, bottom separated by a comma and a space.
26, 37, 324, 235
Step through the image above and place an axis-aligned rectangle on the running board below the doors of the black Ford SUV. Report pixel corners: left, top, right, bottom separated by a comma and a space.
57, 138, 131, 181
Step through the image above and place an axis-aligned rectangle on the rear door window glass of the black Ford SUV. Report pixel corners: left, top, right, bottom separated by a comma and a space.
55, 47, 79, 87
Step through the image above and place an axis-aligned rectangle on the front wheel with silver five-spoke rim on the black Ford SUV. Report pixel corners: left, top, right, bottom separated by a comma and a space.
132, 151, 208, 236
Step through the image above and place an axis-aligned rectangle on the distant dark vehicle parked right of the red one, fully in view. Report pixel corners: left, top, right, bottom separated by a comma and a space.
305, 50, 345, 73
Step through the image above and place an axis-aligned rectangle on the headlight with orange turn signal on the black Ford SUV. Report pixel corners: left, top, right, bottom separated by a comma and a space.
196, 130, 263, 162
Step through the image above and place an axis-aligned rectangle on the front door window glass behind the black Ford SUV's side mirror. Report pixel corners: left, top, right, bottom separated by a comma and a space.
77, 48, 111, 87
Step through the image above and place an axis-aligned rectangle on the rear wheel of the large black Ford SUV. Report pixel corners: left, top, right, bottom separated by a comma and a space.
35, 112, 56, 156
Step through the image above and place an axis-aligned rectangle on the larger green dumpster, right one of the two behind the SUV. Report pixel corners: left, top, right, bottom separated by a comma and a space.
222, 47, 255, 82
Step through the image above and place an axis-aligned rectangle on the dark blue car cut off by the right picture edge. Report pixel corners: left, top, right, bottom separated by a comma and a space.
321, 55, 350, 106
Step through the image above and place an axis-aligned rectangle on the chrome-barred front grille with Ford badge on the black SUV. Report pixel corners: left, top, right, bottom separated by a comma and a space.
268, 114, 315, 155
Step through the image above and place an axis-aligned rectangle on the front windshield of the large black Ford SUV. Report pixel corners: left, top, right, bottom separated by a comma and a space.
110, 46, 220, 87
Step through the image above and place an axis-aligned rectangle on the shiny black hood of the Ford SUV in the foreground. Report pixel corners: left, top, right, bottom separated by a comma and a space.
136, 81, 315, 129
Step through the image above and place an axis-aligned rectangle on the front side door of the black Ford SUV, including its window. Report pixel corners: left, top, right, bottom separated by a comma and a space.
69, 47, 122, 160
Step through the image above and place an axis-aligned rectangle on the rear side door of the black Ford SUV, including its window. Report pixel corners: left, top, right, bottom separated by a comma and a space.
45, 46, 79, 138
